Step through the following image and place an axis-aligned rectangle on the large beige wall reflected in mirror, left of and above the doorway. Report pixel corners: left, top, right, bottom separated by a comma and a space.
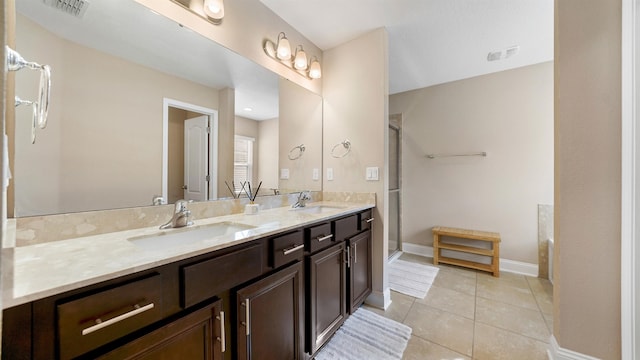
14, 16, 218, 216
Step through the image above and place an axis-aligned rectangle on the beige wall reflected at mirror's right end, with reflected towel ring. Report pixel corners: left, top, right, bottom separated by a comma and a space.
278, 78, 322, 191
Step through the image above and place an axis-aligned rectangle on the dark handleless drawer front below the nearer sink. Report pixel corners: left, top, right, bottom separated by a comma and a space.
180, 244, 262, 308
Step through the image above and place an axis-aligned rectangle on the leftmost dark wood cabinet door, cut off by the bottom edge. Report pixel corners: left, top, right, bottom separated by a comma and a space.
97, 300, 226, 360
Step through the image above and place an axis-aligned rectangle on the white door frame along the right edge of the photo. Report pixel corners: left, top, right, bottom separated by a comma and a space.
620, 0, 640, 359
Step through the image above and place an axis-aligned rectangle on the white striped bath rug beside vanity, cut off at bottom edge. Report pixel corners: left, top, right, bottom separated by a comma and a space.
315, 307, 411, 360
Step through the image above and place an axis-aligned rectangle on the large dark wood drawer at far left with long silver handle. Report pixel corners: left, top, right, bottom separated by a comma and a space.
57, 274, 162, 359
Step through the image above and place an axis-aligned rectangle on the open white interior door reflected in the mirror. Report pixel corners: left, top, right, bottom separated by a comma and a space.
183, 115, 209, 201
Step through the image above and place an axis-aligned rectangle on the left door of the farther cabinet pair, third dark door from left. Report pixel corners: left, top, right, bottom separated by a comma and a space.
307, 242, 347, 354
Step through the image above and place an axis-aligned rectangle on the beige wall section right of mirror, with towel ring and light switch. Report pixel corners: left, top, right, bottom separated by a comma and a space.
322, 29, 389, 306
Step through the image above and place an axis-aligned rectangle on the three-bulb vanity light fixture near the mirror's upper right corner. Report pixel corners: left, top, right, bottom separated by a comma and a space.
263, 32, 322, 79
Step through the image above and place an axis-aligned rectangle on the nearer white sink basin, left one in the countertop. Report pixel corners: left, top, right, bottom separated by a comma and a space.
127, 221, 255, 249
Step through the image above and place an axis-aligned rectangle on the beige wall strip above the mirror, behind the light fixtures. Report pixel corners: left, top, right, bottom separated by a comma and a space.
135, 0, 323, 95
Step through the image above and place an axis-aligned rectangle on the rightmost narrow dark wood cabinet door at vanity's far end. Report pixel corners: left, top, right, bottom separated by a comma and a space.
348, 230, 371, 313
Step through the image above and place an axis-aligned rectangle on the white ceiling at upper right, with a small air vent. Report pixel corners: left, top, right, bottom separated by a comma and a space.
262, 0, 553, 94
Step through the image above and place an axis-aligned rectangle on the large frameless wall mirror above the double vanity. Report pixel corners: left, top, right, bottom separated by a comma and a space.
11, 0, 322, 217
